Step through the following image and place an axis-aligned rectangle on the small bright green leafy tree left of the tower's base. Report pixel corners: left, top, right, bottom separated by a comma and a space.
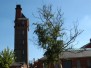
0, 48, 14, 68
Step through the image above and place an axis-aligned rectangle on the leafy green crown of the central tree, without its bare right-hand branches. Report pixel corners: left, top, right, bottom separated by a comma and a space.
34, 5, 64, 62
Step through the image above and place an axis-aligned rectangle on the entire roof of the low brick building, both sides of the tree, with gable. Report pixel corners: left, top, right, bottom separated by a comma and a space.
35, 39, 91, 60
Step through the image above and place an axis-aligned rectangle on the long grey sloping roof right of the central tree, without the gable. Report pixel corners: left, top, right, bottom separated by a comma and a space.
60, 49, 91, 59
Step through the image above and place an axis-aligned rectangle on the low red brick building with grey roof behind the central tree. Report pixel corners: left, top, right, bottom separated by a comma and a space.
31, 40, 91, 68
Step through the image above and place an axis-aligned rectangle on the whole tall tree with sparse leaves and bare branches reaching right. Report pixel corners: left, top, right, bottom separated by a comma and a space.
34, 5, 81, 68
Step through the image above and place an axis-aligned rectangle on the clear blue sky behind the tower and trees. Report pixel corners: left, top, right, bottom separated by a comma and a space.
0, 0, 91, 61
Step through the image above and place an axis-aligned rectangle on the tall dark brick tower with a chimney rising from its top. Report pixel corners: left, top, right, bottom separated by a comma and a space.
14, 5, 29, 65
